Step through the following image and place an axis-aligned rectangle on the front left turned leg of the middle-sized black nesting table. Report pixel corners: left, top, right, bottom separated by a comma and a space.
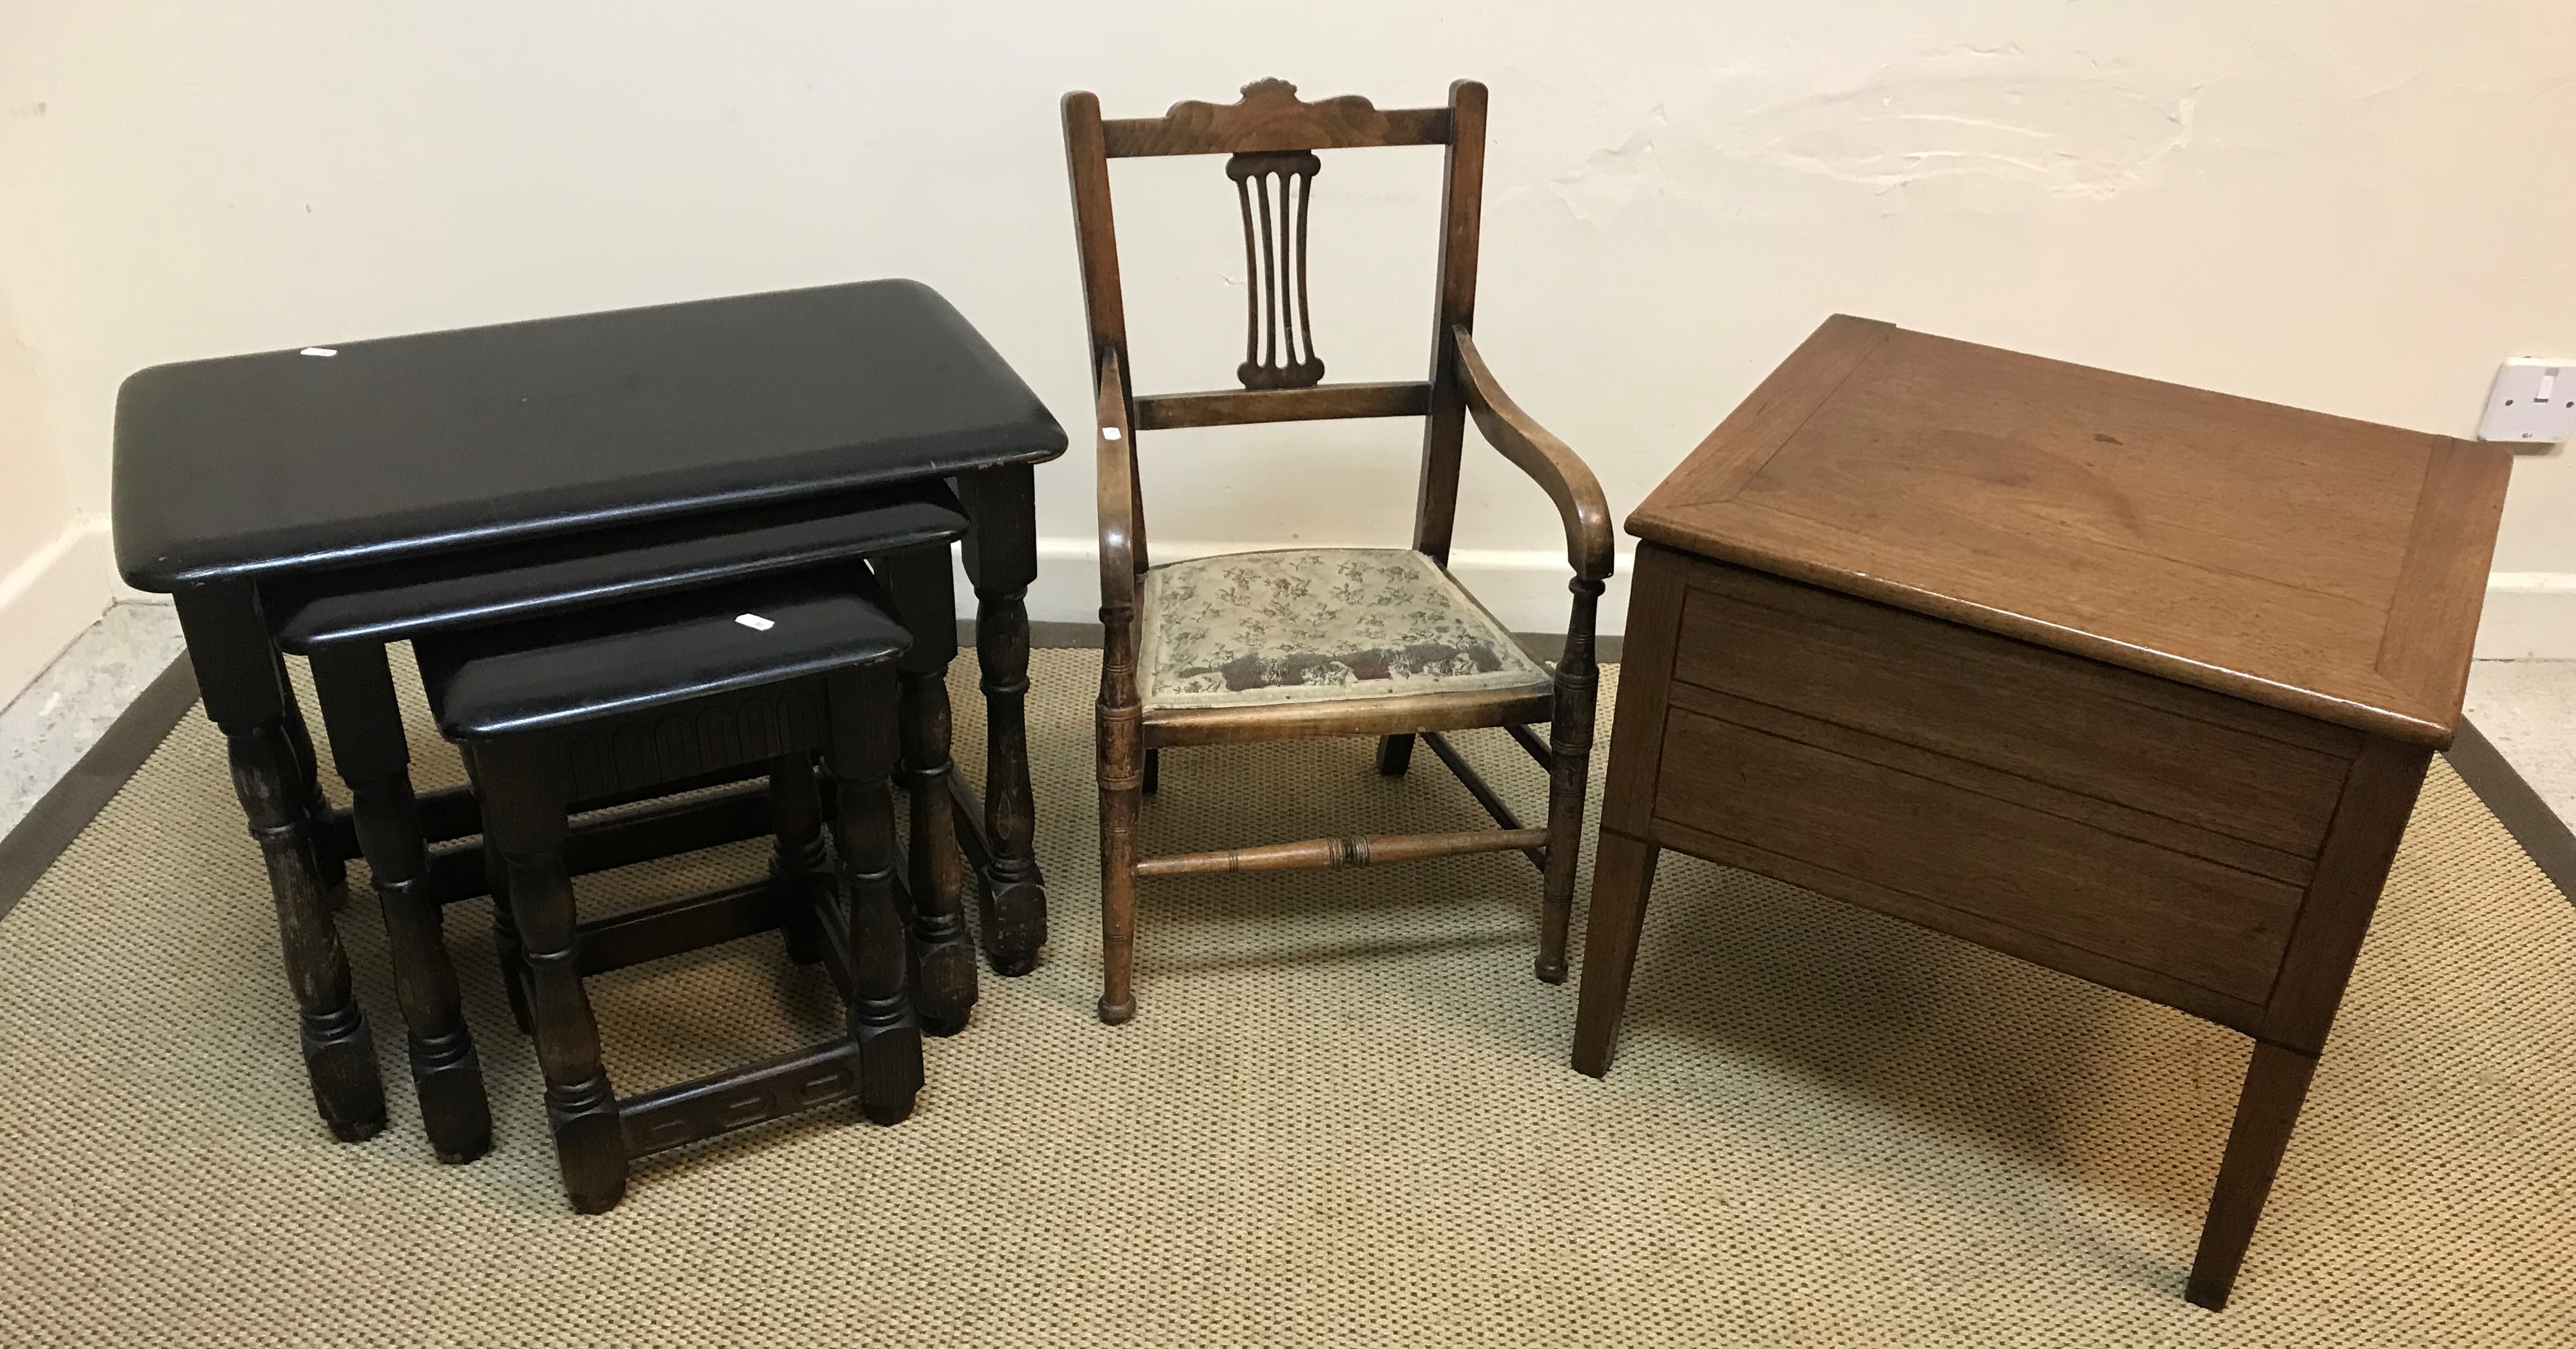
314, 644, 492, 1164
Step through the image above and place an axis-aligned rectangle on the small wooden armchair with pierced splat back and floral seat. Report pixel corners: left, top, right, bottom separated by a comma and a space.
1064, 80, 1613, 1025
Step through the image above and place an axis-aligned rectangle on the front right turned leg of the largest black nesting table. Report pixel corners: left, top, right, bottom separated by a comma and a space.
958, 463, 1046, 976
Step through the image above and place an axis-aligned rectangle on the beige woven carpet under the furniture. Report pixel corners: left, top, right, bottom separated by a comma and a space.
0, 652, 2576, 1346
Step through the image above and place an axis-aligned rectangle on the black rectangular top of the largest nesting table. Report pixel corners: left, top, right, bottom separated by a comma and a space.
113, 280, 1064, 590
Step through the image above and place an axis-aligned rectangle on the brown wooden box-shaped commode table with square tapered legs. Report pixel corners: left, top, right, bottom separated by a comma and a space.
1574, 317, 2506, 1308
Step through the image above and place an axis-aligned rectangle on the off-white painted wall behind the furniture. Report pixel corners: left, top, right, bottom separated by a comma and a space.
0, 0, 2576, 690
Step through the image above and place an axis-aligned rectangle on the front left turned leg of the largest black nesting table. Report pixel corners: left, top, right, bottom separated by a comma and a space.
178, 582, 384, 1143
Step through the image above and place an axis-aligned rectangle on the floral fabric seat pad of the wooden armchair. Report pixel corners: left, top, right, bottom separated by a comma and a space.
1136, 549, 1548, 708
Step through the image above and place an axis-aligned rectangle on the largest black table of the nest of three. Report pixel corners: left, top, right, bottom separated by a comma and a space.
113, 280, 1064, 1141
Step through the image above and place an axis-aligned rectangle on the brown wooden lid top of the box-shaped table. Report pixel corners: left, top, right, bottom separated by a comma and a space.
1628, 314, 2509, 747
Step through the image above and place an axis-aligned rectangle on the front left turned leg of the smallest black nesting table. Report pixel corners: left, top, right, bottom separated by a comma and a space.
477, 744, 626, 1212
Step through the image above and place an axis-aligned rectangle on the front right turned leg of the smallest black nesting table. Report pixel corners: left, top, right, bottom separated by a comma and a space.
824, 669, 922, 1125
